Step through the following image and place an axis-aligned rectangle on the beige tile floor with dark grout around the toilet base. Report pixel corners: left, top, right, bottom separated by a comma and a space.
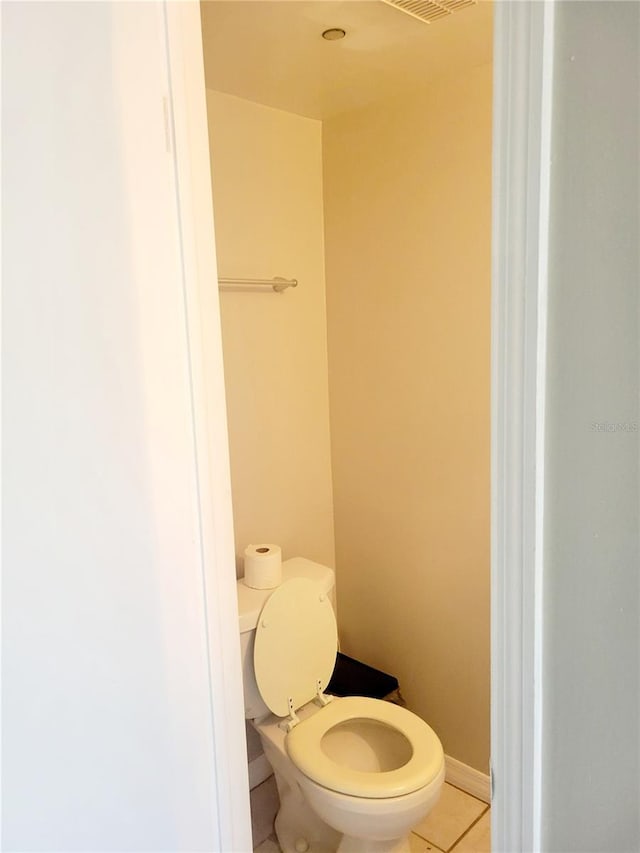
255, 783, 491, 853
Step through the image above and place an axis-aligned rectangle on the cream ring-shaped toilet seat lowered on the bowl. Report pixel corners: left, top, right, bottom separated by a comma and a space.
285, 696, 444, 799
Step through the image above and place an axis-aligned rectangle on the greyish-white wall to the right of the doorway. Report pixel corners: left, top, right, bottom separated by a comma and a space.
542, 2, 640, 853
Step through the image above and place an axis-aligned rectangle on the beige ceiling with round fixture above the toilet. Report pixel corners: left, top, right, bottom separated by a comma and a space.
200, 0, 493, 119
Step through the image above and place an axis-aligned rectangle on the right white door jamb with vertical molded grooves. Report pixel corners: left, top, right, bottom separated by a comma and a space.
491, 0, 554, 853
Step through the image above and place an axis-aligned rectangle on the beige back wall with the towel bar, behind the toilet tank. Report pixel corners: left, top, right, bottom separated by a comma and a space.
207, 91, 334, 574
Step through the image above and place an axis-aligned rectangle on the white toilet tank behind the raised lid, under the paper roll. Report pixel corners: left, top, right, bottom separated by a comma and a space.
237, 557, 335, 720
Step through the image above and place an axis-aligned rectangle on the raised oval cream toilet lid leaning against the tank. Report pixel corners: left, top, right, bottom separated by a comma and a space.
253, 578, 338, 717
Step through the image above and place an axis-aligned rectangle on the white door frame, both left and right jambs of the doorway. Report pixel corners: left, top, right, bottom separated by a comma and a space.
166, 0, 554, 853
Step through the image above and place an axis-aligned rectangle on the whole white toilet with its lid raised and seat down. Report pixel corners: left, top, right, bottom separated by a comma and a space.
238, 557, 445, 853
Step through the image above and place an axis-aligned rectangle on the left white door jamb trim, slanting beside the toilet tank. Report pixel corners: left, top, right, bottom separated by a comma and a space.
163, 0, 253, 853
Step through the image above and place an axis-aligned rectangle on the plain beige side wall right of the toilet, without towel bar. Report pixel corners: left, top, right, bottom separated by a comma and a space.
323, 67, 491, 772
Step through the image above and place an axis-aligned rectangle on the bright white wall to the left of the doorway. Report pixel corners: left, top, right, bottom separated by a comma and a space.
2, 3, 250, 853
